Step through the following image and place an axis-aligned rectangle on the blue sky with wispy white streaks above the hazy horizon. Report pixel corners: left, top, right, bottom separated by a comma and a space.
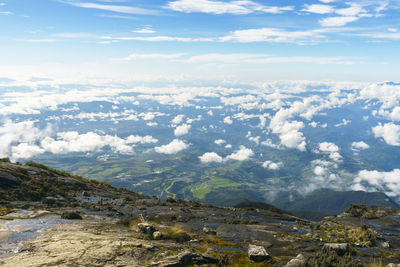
0, 0, 400, 83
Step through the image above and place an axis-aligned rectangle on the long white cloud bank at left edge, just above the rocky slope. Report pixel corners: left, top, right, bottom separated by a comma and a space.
0, 121, 158, 159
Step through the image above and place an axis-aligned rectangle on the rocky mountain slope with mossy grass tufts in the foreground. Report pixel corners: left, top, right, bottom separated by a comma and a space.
0, 161, 400, 266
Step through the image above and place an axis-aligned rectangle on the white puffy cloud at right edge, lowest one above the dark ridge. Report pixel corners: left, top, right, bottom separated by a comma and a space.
352, 169, 400, 198
